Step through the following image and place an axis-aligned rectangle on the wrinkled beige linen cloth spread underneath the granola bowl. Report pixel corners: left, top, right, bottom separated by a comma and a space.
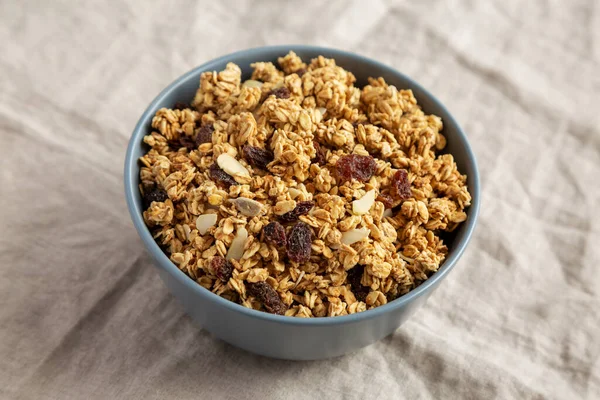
0, 0, 600, 400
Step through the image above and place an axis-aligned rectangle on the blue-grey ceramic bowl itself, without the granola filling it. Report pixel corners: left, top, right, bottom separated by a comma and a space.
125, 45, 480, 360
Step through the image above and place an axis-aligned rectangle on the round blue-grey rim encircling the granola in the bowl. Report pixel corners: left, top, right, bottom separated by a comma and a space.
124, 45, 480, 326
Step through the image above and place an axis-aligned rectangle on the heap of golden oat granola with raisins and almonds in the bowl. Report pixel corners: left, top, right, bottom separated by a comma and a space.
140, 52, 471, 317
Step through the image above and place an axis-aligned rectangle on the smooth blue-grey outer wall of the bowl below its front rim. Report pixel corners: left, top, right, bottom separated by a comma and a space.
158, 255, 431, 360
